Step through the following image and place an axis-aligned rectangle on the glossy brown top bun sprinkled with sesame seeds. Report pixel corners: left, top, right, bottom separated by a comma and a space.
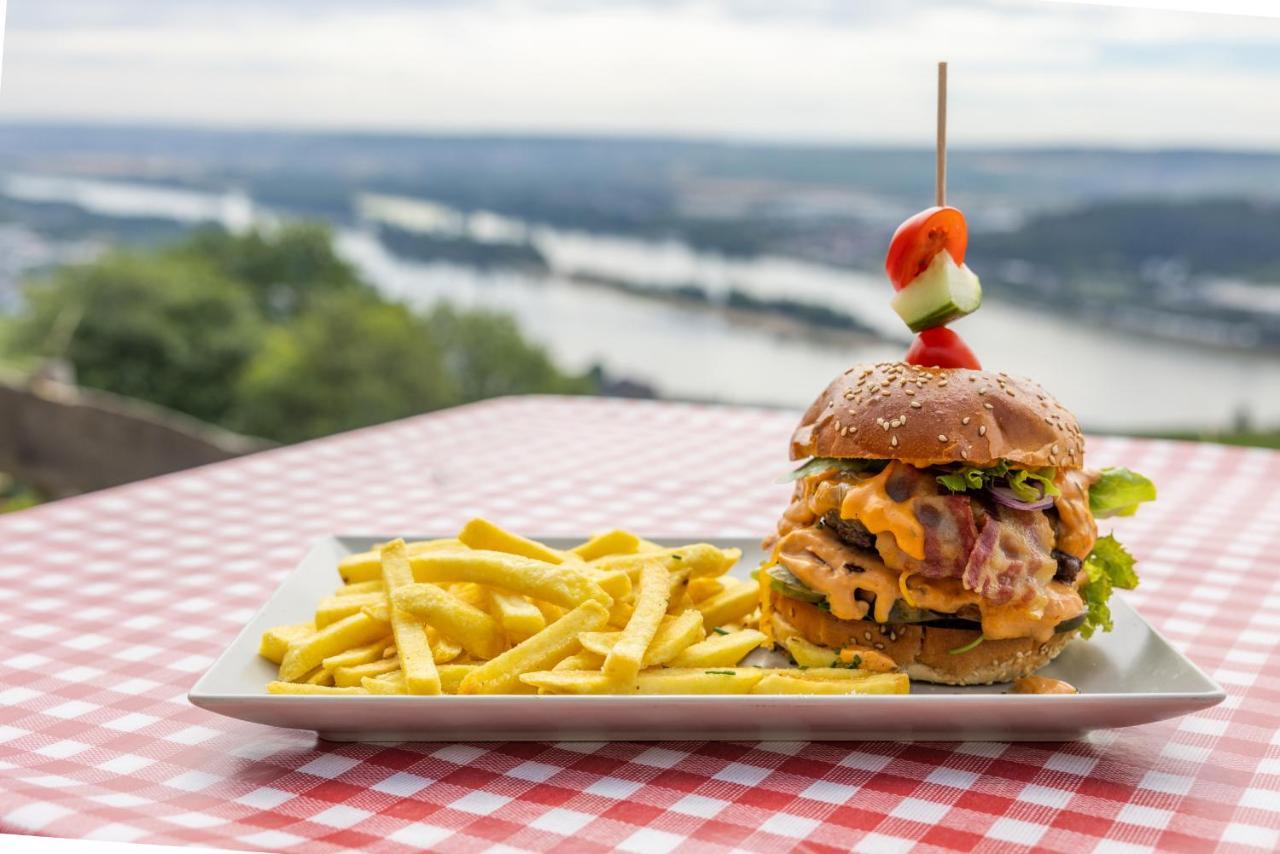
791, 362, 1084, 469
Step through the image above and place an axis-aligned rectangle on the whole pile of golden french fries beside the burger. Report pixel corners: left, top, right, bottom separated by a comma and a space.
259, 519, 909, 702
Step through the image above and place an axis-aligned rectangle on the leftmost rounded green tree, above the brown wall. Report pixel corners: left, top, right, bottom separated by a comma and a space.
15, 252, 262, 423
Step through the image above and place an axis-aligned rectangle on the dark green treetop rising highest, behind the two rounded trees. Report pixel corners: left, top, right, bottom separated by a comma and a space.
170, 222, 370, 321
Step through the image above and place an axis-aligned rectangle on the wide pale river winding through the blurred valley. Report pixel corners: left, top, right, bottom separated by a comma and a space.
0, 175, 1280, 431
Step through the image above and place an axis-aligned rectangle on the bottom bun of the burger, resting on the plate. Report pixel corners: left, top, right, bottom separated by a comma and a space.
769, 592, 1075, 685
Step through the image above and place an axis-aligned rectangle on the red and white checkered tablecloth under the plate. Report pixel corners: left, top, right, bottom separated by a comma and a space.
0, 398, 1280, 853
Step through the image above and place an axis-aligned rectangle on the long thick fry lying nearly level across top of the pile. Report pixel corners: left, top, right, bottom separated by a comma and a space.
412, 549, 613, 608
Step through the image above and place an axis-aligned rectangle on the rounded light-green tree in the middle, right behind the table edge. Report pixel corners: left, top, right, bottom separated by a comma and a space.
232, 293, 458, 442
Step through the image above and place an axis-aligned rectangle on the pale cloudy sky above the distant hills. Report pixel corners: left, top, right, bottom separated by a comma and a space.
0, 0, 1280, 150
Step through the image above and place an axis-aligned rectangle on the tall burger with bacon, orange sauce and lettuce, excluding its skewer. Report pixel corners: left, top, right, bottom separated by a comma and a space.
758, 362, 1155, 685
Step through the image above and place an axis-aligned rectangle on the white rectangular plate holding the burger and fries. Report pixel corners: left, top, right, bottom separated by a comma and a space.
189, 536, 1224, 741
